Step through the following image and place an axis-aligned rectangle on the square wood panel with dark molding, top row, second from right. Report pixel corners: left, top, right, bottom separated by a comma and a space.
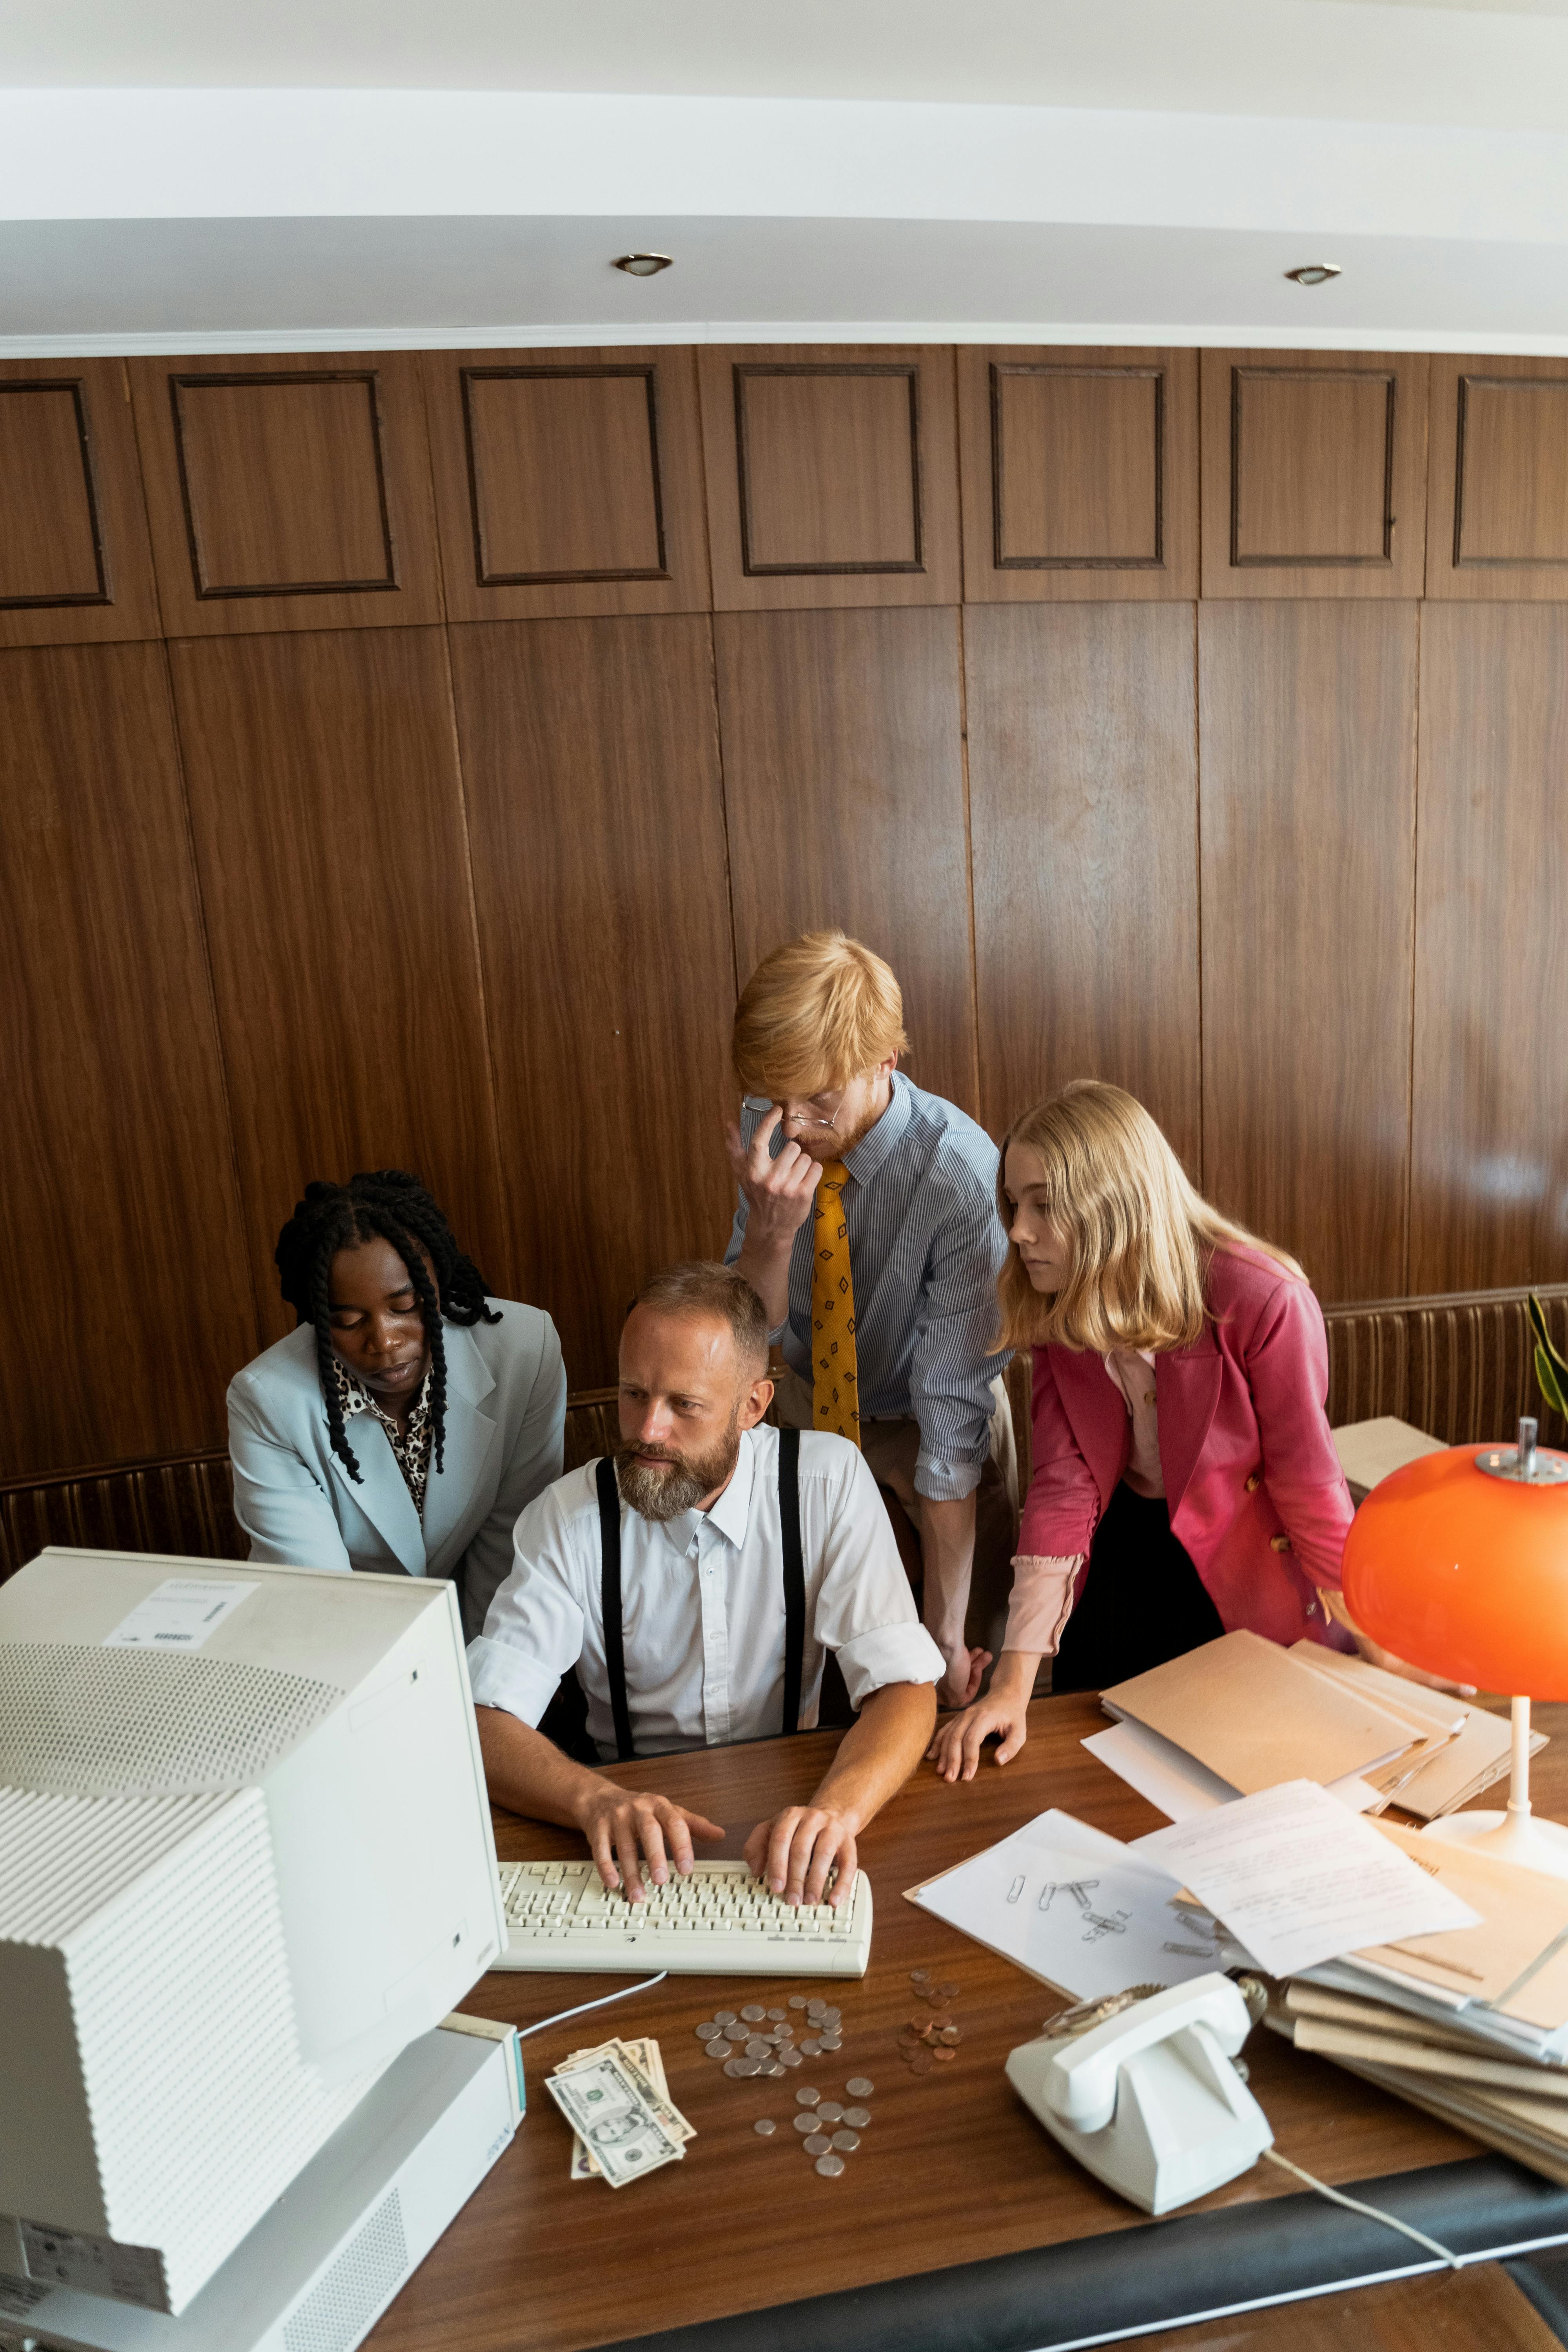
1201, 350, 1427, 597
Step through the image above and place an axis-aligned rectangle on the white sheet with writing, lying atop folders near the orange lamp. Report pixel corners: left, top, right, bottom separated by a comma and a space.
1129, 1780, 1481, 1976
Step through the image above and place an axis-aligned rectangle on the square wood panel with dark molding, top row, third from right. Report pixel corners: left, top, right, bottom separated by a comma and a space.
957, 346, 1199, 604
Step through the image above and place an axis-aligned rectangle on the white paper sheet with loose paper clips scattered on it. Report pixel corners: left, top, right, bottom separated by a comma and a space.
912, 1811, 1246, 2002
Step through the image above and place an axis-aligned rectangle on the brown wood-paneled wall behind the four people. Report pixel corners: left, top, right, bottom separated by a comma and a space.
0, 346, 1568, 1477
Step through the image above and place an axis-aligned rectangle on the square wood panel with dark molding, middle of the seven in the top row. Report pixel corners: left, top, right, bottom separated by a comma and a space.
698, 343, 959, 612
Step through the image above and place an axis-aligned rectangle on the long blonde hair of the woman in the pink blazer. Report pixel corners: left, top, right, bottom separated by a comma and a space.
997, 1077, 1307, 1355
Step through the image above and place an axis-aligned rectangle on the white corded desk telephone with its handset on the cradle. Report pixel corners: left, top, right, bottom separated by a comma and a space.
1006, 1976, 1274, 2213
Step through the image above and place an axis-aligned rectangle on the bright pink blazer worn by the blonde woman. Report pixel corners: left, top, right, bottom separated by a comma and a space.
1018, 1249, 1354, 1649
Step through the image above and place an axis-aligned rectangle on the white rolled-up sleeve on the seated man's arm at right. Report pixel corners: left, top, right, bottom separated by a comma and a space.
813, 1446, 947, 1708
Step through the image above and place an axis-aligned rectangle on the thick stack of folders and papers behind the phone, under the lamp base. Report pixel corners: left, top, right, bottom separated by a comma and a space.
1269, 1823, 1568, 2185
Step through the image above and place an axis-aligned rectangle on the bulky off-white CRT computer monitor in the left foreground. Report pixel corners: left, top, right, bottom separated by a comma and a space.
0, 1548, 505, 2314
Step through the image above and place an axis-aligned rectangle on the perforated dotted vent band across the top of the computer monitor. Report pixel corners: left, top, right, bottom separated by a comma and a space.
0, 1642, 343, 1797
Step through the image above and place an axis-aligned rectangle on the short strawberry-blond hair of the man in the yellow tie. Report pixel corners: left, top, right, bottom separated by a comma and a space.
731, 931, 910, 1098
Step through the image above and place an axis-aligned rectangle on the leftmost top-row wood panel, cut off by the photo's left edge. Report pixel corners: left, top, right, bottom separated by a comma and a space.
0, 360, 160, 647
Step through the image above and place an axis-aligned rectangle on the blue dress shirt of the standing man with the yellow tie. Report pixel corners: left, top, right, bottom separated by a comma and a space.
724, 1070, 1006, 1501
